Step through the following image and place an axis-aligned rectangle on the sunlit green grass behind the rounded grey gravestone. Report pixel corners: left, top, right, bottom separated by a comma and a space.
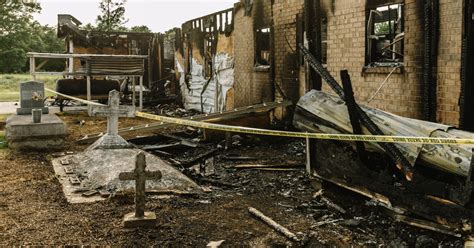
0, 74, 62, 102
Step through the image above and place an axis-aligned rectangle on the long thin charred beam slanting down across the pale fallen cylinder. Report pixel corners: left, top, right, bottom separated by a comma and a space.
299, 44, 413, 181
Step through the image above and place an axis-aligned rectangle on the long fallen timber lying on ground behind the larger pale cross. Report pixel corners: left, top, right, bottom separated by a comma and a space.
76, 101, 291, 144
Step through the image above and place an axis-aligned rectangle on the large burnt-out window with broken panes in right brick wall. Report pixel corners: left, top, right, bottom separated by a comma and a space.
367, 4, 405, 66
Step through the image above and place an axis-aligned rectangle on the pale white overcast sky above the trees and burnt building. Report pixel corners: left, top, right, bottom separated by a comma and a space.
35, 0, 238, 32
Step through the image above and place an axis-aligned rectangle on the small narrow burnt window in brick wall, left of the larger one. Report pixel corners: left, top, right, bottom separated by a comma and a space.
254, 27, 272, 70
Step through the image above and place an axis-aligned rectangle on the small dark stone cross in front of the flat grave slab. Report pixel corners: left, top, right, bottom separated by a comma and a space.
119, 152, 161, 228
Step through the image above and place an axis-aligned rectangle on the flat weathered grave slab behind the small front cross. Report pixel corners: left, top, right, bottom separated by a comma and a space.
52, 149, 202, 203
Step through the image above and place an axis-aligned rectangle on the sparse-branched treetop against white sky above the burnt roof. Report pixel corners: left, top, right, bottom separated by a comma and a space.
96, 0, 128, 32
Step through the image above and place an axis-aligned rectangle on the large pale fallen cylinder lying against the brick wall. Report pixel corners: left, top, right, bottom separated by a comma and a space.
294, 90, 474, 177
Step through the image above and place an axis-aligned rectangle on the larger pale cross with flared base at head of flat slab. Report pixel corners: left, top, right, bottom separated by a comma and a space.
88, 90, 135, 149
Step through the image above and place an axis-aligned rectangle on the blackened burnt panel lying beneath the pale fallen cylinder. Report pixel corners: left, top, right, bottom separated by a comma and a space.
308, 140, 474, 237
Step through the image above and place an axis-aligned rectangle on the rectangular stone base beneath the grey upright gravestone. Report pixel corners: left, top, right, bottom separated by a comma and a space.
5, 114, 67, 150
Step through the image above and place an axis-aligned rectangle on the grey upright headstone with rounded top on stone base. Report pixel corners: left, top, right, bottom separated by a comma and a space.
16, 81, 49, 115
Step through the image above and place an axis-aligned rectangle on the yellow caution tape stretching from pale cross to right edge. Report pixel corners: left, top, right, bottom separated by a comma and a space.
135, 111, 474, 145
